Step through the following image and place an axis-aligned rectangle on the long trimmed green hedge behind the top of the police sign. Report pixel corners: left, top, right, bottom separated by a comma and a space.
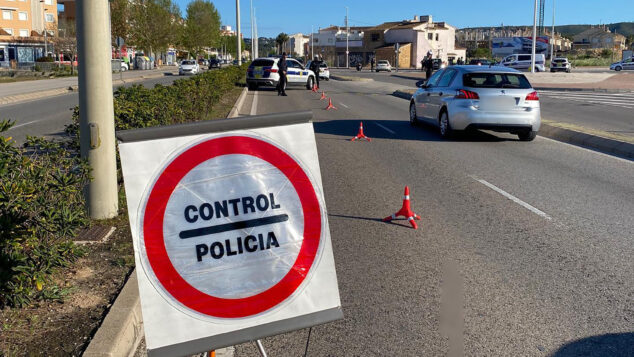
66, 64, 248, 136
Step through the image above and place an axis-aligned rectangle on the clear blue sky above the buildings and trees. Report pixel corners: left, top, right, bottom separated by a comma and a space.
174, 0, 634, 37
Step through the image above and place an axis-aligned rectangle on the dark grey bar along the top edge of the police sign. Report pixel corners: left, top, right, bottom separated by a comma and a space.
116, 111, 313, 143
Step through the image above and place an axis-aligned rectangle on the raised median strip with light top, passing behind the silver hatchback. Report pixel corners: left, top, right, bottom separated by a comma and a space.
392, 89, 634, 159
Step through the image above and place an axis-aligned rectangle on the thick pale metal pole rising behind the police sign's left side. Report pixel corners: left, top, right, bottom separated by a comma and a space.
77, 0, 119, 219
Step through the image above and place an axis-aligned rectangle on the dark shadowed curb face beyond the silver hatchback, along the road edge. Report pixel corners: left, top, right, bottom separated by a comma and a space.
392, 90, 634, 159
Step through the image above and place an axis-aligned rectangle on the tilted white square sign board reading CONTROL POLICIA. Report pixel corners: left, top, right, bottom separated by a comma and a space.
119, 117, 342, 356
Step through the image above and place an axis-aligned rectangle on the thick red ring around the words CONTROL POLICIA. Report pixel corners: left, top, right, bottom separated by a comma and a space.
143, 136, 321, 318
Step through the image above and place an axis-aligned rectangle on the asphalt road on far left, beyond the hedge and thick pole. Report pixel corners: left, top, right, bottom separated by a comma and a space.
0, 76, 179, 143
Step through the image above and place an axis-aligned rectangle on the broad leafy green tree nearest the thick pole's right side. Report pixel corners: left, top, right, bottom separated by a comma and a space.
129, 0, 181, 53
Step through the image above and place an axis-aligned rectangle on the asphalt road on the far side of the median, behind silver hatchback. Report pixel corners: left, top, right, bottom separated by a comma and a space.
333, 70, 634, 141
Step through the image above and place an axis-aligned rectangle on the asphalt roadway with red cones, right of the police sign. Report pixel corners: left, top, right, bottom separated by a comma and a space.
236, 81, 634, 357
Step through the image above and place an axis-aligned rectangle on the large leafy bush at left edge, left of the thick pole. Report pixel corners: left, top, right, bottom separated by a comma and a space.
0, 120, 89, 308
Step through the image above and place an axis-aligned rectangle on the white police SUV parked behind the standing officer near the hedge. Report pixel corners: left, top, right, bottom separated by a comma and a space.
247, 57, 315, 90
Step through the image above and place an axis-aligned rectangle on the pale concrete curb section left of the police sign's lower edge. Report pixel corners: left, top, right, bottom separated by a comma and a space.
83, 269, 143, 357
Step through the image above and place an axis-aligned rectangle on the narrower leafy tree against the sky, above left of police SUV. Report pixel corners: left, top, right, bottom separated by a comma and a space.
182, 0, 220, 55
